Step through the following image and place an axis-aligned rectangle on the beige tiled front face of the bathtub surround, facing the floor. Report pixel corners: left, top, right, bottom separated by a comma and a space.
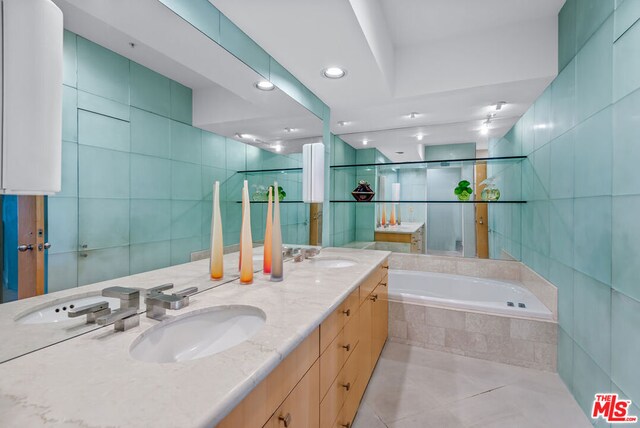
389, 301, 558, 371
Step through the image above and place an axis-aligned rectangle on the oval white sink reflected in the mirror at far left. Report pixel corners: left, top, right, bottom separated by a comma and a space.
16, 292, 120, 324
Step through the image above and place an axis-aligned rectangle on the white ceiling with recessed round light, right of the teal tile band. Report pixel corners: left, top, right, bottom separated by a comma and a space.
209, 0, 564, 160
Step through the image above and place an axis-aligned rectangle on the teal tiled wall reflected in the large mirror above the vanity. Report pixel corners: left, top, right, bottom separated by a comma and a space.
48, 30, 309, 291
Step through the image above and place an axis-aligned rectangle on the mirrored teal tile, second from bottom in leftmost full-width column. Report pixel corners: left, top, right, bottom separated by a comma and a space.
78, 198, 129, 250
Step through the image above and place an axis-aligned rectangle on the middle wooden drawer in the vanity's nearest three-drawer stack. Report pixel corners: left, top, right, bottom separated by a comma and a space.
320, 311, 360, 398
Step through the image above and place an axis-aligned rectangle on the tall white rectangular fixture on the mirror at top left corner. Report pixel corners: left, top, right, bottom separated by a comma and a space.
0, 0, 64, 195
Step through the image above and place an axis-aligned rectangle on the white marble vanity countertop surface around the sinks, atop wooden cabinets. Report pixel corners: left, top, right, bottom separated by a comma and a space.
0, 248, 390, 427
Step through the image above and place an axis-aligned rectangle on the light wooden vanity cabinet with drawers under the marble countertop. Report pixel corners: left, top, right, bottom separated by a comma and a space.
218, 261, 388, 428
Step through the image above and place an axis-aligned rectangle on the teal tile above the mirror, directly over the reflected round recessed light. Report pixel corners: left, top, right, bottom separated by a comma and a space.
220, 15, 270, 78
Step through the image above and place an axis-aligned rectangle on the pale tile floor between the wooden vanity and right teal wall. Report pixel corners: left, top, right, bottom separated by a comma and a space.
353, 342, 591, 428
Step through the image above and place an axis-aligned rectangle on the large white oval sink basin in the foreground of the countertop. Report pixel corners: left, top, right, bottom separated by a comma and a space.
129, 305, 267, 363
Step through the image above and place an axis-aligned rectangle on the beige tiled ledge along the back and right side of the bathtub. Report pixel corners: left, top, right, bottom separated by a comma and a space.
389, 253, 558, 320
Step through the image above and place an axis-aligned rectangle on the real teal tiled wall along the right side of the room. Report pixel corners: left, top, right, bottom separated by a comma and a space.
490, 0, 640, 422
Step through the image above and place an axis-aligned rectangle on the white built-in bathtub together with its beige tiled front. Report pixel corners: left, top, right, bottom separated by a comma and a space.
388, 269, 557, 371
